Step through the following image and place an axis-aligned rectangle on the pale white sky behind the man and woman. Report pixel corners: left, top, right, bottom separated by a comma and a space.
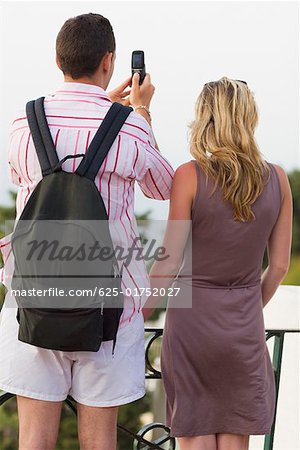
0, 1, 300, 218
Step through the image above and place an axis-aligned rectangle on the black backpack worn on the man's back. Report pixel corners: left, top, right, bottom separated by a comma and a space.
11, 97, 132, 352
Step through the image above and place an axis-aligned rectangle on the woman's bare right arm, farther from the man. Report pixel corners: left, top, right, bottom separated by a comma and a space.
261, 164, 293, 307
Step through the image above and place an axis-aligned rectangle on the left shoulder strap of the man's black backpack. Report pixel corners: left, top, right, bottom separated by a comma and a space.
26, 97, 59, 177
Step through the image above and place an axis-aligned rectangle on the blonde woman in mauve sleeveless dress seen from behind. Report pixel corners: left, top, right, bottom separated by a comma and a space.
144, 77, 292, 450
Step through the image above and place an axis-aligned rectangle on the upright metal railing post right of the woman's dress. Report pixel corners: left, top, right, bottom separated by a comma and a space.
264, 331, 284, 450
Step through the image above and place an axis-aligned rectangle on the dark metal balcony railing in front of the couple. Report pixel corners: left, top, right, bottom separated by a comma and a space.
0, 327, 300, 450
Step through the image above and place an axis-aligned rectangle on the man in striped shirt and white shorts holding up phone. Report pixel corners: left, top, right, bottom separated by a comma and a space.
0, 14, 173, 450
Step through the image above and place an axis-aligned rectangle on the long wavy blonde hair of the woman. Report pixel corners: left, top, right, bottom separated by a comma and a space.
190, 77, 270, 222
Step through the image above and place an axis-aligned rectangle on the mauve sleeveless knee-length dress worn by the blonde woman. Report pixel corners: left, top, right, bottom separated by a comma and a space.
161, 160, 281, 437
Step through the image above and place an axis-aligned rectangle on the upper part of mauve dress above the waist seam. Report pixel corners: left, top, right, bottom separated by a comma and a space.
183, 160, 281, 286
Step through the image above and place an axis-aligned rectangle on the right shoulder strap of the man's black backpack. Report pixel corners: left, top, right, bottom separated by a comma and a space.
76, 102, 133, 180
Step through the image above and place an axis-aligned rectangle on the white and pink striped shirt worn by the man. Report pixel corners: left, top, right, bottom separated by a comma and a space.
0, 82, 174, 327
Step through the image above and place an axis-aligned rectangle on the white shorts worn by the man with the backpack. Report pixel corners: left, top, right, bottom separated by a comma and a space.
0, 298, 145, 406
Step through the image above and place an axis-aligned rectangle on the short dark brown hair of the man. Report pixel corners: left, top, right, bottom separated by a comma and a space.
56, 13, 116, 79
